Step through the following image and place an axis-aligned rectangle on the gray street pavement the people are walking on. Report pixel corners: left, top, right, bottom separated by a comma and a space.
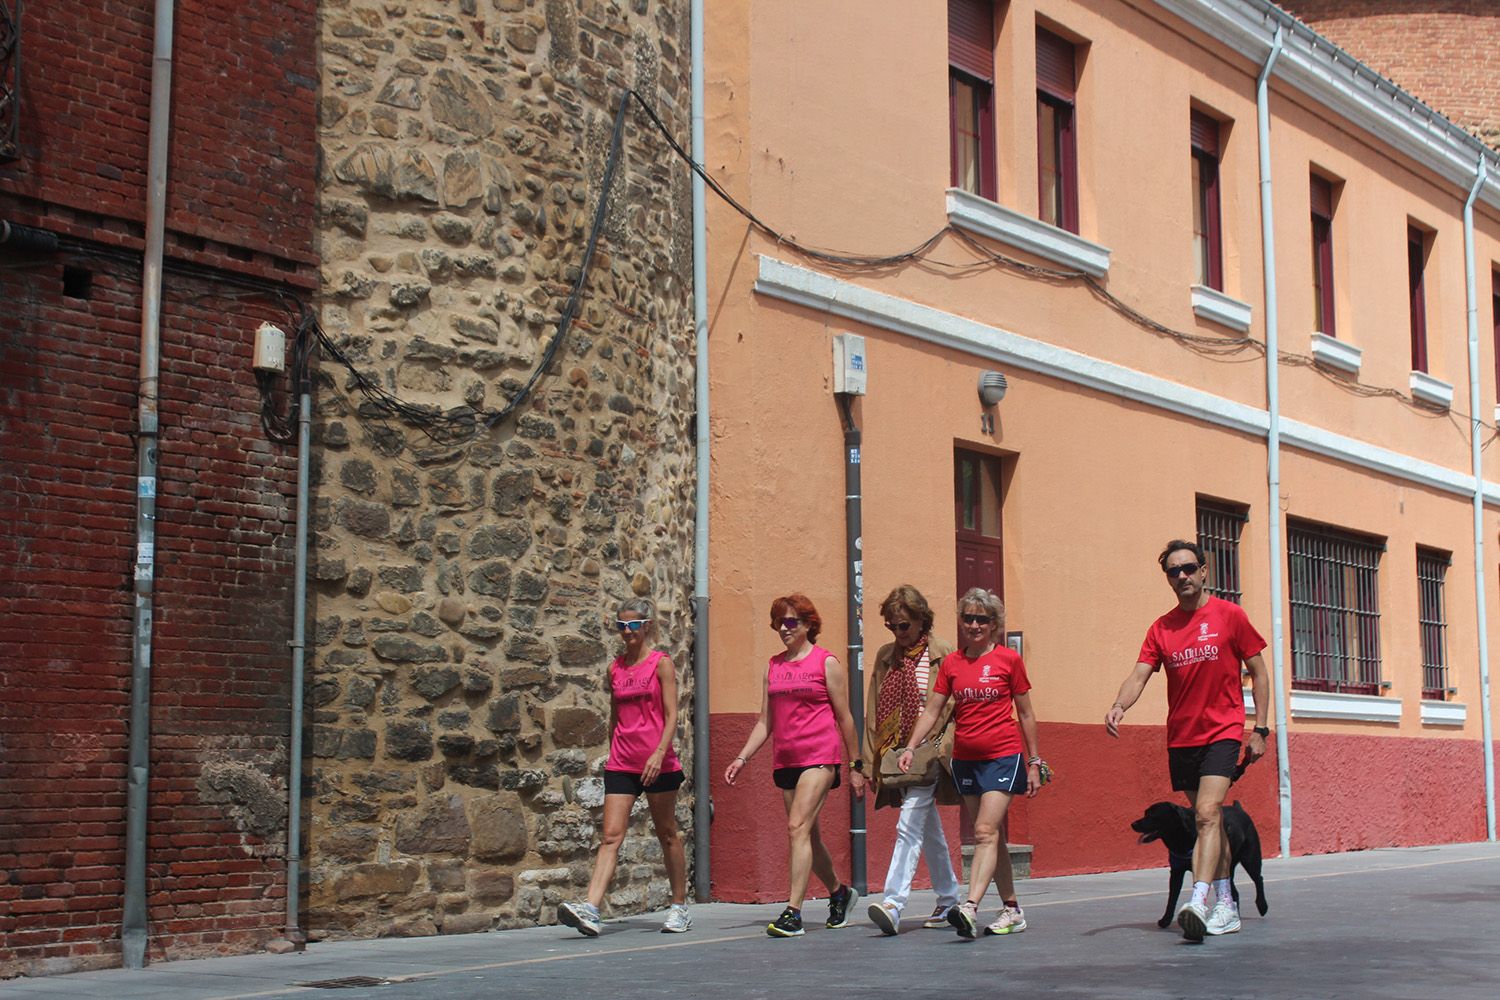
11, 844, 1500, 1000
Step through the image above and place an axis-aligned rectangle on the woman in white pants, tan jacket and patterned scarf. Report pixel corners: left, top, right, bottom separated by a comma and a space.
864, 583, 960, 936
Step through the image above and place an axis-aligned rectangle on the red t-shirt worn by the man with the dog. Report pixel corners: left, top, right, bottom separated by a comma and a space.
1137, 597, 1266, 747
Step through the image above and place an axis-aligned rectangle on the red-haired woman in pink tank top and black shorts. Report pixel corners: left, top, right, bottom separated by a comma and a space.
725, 594, 864, 937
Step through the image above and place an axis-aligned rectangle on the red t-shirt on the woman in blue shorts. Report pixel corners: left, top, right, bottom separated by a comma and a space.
933, 646, 1031, 760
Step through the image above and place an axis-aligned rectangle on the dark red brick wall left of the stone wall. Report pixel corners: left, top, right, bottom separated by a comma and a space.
0, 0, 317, 978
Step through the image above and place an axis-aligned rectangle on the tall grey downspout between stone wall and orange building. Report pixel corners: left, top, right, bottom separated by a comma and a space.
689, 0, 714, 903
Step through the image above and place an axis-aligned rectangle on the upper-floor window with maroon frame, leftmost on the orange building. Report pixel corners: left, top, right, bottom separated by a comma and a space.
948, 0, 996, 201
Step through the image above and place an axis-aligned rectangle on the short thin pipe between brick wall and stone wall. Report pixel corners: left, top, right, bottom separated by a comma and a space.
285, 389, 312, 945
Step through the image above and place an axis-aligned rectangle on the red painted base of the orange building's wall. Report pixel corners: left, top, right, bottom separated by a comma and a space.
711, 714, 1485, 903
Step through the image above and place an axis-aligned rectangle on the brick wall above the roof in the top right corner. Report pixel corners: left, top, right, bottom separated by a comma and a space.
1281, 0, 1500, 145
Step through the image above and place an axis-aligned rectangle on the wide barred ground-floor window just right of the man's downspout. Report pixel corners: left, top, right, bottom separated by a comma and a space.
1287, 522, 1385, 694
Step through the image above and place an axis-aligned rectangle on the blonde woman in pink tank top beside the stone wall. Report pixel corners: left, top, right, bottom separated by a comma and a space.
558, 598, 693, 937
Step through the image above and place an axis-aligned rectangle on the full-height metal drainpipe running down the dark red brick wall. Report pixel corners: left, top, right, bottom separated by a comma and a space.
120, 0, 174, 969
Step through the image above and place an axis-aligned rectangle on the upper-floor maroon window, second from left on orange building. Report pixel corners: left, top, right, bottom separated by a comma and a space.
1037, 28, 1079, 232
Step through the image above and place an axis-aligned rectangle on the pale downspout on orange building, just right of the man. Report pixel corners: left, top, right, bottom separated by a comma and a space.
1256, 24, 1292, 858
